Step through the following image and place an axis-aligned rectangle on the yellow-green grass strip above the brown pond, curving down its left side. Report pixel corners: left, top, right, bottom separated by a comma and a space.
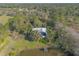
8, 39, 45, 56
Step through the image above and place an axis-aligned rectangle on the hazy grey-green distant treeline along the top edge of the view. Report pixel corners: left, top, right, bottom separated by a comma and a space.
0, 3, 79, 8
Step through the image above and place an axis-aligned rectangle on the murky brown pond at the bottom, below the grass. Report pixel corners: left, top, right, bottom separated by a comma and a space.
18, 48, 64, 56
